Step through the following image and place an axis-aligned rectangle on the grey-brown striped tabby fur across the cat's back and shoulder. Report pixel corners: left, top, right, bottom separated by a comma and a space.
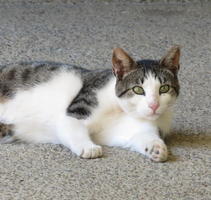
0, 62, 112, 119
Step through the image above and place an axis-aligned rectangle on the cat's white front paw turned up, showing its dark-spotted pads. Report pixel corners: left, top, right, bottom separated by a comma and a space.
145, 139, 168, 162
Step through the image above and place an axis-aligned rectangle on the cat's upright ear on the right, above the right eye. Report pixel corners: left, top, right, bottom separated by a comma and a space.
160, 46, 180, 73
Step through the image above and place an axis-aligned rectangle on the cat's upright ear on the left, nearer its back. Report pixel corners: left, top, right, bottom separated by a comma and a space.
112, 48, 137, 80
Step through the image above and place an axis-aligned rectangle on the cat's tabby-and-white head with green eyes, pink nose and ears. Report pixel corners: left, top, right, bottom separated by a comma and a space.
112, 46, 180, 120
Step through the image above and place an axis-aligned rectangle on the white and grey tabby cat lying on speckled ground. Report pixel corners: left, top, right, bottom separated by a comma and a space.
0, 46, 180, 162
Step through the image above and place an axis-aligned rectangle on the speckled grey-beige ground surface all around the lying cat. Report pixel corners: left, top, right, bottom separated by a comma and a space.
0, 0, 211, 200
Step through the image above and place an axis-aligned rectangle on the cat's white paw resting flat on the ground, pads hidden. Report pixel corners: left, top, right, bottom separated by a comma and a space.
80, 144, 103, 158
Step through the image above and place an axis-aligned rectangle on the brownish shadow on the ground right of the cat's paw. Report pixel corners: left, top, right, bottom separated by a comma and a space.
165, 130, 211, 162
